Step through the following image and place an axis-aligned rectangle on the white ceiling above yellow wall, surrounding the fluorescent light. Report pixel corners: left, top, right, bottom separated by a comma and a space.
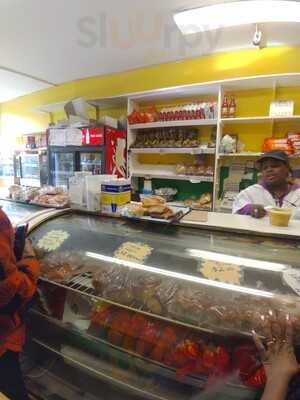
0, 0, 300, 102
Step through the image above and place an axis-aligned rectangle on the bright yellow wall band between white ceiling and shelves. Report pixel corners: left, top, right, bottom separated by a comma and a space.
0, 47, 300, 138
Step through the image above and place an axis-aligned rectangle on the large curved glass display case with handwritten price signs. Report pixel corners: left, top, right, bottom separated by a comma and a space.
26, 212, 300, 400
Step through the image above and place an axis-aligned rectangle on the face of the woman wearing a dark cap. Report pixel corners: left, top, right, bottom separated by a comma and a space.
261, 158, 289, 187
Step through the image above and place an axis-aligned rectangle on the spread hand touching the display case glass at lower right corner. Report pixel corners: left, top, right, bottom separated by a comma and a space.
253, 317, 300, 384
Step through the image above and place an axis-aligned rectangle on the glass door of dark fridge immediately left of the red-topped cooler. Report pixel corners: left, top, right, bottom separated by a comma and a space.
51, 152, 75, 186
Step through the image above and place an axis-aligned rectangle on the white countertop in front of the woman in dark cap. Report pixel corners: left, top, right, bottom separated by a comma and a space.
180, 210, 300, 239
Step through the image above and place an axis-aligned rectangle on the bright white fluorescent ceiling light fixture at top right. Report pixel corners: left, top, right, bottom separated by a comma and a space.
174, 0, 300, 35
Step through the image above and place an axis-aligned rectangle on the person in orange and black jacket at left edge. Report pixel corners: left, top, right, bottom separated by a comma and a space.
0, 210, 39, 400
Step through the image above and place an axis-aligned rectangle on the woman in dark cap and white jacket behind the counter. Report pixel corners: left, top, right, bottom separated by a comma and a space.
233, 151, 300, 218
